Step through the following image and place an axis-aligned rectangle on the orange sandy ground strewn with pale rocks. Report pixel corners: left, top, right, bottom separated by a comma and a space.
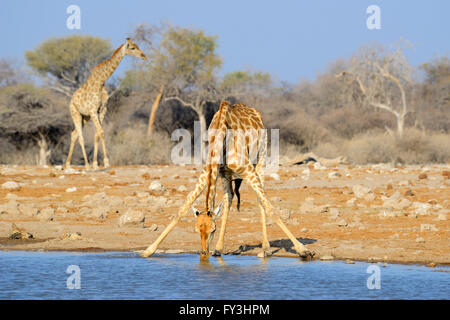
0, 165, 450, 264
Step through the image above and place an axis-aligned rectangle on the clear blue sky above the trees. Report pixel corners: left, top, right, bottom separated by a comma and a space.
0, 0, 450, 83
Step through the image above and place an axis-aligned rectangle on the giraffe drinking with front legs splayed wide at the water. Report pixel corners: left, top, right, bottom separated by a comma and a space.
141, 101, 313, 260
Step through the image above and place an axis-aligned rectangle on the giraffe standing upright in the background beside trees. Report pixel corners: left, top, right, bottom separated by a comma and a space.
66, 38, 147, 169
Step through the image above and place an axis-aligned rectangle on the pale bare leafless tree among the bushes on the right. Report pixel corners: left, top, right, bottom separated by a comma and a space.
336, 42, 413, 138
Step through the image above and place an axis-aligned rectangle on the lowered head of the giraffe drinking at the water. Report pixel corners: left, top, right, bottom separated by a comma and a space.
192, 203, 222, 260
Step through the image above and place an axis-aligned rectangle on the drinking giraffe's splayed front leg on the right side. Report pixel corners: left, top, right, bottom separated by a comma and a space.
245, 171, 314, 258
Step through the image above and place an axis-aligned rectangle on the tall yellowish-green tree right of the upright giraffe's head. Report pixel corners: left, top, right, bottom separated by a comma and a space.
127, 24, 222, 155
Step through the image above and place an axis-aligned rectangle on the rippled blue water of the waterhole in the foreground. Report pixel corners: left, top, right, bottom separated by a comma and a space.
0, 251, 450, 299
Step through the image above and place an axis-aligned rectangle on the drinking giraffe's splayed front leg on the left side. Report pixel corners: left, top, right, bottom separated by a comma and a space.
141, 170, 208, 257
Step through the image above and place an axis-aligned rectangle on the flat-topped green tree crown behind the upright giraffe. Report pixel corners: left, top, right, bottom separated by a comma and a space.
25, 35, 112, 97
